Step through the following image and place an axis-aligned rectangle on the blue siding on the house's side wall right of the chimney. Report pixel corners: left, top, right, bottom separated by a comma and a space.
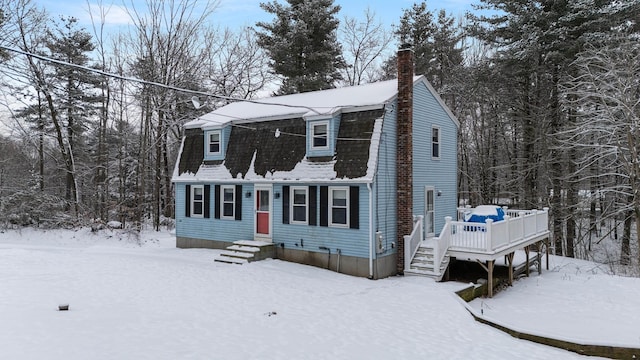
413, 82, 458, 236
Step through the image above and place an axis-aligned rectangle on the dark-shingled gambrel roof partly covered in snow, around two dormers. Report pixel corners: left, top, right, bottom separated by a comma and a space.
173, 76, 457, 182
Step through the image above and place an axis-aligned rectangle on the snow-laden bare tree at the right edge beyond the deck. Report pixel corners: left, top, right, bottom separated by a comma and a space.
559, 37, 640, 263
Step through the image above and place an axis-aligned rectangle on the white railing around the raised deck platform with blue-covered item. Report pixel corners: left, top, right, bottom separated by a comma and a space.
440, 208, 549, 252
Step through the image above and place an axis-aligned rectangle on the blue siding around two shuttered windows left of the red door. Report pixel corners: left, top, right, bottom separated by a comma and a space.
176, 183, 254, 242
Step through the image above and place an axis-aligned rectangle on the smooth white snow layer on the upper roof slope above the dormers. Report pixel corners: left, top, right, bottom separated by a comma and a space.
185, 76, 420, 129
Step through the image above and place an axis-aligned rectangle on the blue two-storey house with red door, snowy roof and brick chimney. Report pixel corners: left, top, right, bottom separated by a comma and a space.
173, 47, 459, 279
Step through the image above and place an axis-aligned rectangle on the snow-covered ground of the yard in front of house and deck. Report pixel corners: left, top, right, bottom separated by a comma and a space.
0, 229, 640, 359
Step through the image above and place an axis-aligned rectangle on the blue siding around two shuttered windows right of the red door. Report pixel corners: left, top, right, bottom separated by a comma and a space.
273, 183, 369, 258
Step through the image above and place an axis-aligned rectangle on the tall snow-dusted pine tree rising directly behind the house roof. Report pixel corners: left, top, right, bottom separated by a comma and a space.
256, 0, 345, 94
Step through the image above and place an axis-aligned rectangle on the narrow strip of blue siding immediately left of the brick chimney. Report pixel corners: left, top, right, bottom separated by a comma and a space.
373, 102, 398, 257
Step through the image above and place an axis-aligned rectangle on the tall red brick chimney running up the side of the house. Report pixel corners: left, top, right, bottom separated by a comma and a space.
396, 44, 413, 274
